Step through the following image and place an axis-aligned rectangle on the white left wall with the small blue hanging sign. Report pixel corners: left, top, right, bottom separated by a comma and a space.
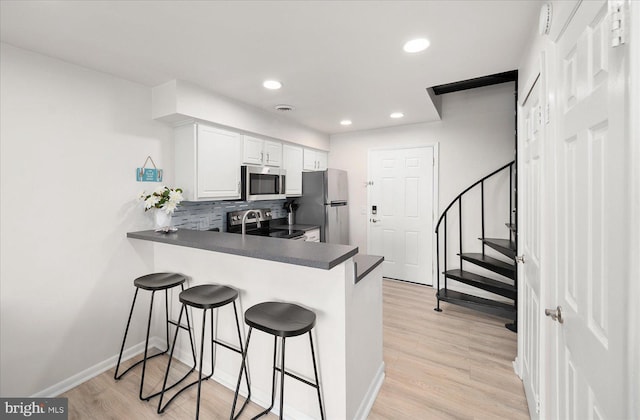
0, 44, 173, 397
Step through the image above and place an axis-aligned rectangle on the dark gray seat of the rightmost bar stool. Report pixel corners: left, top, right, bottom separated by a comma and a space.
244, 302, 316, 337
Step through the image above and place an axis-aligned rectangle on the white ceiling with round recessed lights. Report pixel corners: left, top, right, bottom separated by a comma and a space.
0, 0, 541, 134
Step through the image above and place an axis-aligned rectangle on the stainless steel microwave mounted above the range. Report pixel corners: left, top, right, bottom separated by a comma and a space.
241, 166, 286, 201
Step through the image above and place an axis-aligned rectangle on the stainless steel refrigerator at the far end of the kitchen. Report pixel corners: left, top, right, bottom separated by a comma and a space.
296, 169, 349, 245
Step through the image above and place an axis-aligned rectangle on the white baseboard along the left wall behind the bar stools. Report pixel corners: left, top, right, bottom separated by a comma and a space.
31, 337, 166, 398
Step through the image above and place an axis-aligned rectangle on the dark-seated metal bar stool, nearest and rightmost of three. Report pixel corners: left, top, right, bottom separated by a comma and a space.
231, 302, 324, 420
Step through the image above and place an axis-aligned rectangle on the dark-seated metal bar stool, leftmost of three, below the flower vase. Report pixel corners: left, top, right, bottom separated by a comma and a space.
113, 273, 196, 401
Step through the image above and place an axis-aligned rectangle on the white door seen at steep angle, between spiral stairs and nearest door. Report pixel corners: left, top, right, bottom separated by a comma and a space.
518, 70, 545, 419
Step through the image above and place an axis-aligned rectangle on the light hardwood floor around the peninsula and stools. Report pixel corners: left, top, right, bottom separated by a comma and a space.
61, 280, 529, 420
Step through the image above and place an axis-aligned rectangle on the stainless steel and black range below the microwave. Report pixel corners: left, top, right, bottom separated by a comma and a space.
227, 209, 304, 240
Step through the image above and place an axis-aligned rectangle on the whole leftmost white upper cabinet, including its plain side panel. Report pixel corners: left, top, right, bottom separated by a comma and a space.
174, 124, 242, 201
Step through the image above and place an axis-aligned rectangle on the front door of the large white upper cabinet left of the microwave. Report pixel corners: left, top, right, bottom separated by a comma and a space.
196, 124, 242, 200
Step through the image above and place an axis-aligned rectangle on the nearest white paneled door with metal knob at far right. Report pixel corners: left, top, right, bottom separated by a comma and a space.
546, 0, 638, 420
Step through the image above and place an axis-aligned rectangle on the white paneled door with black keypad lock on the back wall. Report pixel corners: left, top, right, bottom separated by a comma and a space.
368, 147, 434, 285
